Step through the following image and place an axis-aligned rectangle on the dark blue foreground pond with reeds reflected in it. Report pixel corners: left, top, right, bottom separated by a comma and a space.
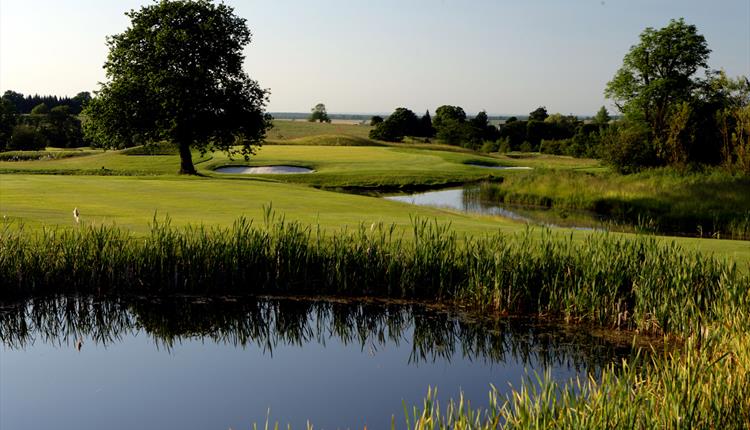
0, 297, 632, 429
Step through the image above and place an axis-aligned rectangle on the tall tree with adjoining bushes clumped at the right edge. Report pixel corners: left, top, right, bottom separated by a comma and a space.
605, 19, 750, 171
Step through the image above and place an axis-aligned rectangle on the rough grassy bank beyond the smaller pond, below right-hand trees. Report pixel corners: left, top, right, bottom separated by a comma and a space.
482, 169, 750, 239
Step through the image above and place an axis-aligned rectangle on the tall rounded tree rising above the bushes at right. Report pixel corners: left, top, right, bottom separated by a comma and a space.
605, 19, 711, 151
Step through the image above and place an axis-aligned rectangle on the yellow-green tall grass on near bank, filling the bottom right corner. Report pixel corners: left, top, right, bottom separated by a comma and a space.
406, 302, 750, 430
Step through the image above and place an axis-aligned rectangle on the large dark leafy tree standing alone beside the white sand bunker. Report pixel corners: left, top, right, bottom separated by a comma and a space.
84, 0, 271, 174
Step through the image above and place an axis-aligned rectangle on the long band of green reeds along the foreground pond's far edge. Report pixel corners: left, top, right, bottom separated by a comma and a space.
0, 210, 750, 335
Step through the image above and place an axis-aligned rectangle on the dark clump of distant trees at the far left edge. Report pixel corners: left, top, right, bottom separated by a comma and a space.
0, 91, 90, 151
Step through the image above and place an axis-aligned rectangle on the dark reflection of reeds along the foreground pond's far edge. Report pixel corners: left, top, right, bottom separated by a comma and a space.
0, 297, 631, 370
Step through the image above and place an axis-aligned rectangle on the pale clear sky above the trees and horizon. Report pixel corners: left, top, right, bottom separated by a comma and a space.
0, 0, 750, 115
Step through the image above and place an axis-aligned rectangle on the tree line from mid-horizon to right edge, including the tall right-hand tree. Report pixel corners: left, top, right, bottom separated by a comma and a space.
370, 19, 750, 174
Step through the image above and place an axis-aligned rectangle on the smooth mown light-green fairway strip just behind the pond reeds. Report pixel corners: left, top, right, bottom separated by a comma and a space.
0, 174, 750, 270
